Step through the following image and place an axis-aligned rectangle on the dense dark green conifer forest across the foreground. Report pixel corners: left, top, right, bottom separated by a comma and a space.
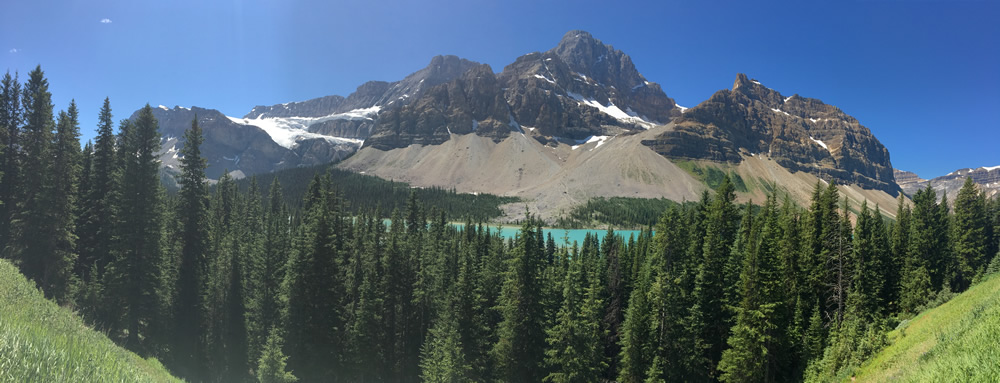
0, 68, 1000, 382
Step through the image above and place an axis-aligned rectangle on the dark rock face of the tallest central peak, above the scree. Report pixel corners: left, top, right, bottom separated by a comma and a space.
365, 31, 680, 150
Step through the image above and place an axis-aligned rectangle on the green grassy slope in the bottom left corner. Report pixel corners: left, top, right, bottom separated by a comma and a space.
0, 260, 179, 382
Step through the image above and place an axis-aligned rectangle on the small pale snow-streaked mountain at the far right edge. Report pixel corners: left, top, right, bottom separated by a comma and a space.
894, 166, 1000, 201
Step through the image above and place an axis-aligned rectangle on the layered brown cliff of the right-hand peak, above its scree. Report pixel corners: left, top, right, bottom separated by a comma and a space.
645, 74, 898, 194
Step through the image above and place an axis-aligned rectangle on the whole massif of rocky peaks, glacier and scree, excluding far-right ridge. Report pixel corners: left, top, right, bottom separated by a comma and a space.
137, 31, 940, 218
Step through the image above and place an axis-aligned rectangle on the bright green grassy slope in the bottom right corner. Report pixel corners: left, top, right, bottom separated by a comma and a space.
856, 275, 1000, 382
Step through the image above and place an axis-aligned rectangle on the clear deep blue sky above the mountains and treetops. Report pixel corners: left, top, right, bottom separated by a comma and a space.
0, 0, 1000, 178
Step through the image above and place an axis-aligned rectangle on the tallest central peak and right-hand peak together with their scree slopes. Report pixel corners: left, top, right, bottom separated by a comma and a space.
340, 31, 899, 217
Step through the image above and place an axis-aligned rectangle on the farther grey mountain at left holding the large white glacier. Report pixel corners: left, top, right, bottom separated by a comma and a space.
145, 56, 478, 179
